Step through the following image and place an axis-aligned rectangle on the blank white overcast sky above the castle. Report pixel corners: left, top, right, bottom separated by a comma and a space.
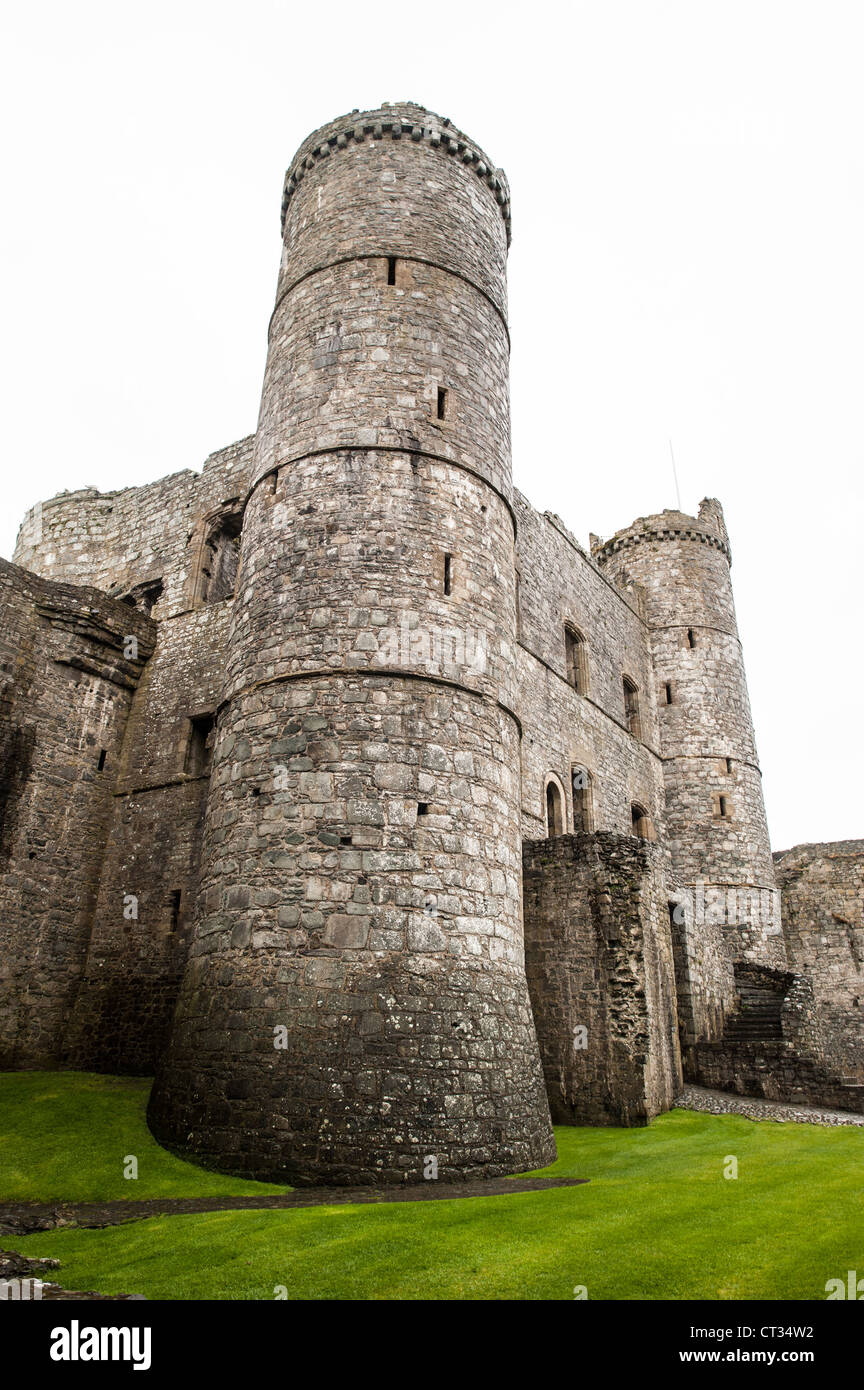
0, 0, 864, 849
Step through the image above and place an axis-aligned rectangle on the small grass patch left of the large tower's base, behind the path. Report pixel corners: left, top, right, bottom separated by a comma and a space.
0, 1072, 290, 1202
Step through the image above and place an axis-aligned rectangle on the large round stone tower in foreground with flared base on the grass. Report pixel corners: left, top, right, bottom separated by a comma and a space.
150, 104, 554, 1183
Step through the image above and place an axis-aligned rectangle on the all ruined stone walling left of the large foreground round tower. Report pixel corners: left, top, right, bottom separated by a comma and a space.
0, 439, 251, 1072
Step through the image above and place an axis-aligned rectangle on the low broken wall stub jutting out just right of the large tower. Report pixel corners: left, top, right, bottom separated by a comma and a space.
524, 831, 681, 1125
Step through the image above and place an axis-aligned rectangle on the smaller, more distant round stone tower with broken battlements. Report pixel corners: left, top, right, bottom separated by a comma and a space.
593, 499, 785, 994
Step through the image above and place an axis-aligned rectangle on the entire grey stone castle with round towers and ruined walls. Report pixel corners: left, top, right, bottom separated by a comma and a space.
0, 103, 864, 1183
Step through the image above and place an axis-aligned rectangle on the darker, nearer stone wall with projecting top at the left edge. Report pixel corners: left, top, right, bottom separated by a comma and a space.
0, 562, 154, 1066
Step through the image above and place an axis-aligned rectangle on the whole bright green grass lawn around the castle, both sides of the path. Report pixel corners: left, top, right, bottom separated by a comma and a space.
0, 1074, 864, 1300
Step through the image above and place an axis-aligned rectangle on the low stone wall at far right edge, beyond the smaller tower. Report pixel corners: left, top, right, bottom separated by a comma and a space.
774, 840, 864, 1084
